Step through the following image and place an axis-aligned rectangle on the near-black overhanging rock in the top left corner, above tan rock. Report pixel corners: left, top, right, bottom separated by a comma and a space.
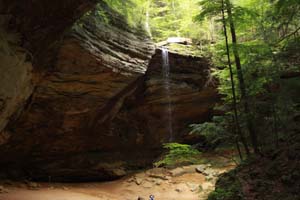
0, 0, 97, 59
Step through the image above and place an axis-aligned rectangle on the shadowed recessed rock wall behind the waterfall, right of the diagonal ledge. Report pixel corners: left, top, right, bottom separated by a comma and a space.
110, 49, 220, 151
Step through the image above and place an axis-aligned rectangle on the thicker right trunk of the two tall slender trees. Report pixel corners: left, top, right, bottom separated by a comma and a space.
225, 0, 260, 154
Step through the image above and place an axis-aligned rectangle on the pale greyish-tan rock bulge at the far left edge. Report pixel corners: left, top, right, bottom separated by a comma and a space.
0, 19, 33, 145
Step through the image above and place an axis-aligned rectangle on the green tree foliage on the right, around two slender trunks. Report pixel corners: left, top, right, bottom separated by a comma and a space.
195, 0, 300, 155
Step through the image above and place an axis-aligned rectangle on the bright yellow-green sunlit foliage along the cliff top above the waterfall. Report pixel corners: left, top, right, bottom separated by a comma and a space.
87, 0, 215, 42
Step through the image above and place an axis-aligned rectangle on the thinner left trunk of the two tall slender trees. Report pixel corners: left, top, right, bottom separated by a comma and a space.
222, 0, 250, 156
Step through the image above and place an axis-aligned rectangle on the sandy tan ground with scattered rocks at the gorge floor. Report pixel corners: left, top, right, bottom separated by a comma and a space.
0, 156, 233, 200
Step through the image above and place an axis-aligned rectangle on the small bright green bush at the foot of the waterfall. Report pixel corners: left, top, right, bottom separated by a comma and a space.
154, 143, 200, 167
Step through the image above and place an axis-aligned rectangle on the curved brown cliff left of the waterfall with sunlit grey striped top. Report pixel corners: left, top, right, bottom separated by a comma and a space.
0, 3, 154, 180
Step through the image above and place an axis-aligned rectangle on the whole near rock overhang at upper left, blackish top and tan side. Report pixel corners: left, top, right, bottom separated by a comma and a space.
0, 0, 97, 139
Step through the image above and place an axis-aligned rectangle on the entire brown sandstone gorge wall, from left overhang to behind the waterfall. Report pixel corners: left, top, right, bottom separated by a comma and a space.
0, 1, 218, 181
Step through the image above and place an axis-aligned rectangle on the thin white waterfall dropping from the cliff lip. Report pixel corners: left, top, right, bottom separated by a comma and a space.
162, 47, 173, 142
